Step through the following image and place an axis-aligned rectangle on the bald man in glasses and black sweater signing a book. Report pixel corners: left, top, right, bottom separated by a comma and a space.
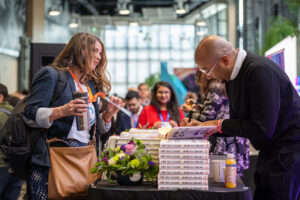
182, 36, 300, 200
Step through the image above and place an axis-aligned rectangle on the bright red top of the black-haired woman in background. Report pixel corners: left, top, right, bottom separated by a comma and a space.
139, 105, 185, 128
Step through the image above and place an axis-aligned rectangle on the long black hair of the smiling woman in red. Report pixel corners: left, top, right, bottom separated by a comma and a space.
150, 81, 180, 124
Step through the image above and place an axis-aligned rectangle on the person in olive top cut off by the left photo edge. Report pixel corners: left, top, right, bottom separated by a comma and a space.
0, 83, 22, 200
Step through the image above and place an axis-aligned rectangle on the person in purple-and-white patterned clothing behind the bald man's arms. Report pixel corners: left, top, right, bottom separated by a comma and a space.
193, 80, 250, 176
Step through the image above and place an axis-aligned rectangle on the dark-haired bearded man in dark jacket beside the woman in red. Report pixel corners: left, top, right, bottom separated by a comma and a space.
117, 91, 143, 134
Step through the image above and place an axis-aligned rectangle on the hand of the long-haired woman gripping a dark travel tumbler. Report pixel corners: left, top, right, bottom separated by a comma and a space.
49, 99, 88, 122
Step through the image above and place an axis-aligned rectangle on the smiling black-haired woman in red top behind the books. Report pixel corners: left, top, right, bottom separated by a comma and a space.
139, 81, 184, 129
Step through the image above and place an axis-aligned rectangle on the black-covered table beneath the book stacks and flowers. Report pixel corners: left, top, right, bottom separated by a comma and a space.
88, 177, 252, 200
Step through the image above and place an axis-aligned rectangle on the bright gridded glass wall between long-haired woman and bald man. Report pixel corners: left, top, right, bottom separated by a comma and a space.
101, 25, 195, 97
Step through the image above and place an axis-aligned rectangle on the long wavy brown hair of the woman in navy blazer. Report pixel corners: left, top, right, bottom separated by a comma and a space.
51, 33, 111, 92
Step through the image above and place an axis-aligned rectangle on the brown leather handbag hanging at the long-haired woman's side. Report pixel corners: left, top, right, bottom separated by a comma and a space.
47, 138, 100, 199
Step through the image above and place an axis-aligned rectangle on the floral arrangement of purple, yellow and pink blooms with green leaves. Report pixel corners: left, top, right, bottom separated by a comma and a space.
91, 138, 158, 182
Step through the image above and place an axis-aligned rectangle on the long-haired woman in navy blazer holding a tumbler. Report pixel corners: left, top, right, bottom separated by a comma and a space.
24, 33, 120, 200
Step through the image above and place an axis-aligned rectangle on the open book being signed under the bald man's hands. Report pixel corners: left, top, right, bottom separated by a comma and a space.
166, 126, 217, 139
